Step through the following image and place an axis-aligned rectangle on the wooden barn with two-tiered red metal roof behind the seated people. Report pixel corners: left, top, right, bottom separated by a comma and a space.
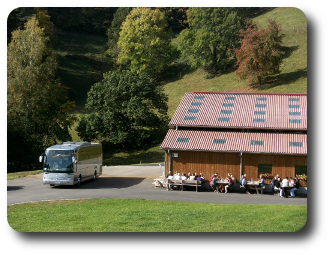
161, 92, 307, 190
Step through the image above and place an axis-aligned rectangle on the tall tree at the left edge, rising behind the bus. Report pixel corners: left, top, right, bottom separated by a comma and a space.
7, 17, 74, 162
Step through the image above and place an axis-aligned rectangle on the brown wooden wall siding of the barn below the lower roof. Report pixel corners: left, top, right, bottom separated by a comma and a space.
165, 150, 307, 186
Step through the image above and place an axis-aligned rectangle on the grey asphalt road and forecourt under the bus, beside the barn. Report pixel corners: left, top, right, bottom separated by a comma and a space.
7, 165, 307, 205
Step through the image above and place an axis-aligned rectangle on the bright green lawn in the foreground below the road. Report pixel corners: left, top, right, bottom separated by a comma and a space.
7, 199, 307, 232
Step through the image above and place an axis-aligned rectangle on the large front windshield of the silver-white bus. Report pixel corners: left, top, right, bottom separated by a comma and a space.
44, 150, 74, 173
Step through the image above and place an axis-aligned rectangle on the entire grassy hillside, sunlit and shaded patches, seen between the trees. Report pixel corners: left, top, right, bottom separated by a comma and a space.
56, 8, 307, 165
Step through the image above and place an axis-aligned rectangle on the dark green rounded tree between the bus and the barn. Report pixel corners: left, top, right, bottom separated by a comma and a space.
77, 70, 168, 147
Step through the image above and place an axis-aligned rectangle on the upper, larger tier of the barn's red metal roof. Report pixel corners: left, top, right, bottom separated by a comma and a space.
169, 92, 307, 131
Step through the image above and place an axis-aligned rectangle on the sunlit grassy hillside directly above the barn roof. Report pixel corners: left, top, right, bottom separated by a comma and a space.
165, 8, 307, 117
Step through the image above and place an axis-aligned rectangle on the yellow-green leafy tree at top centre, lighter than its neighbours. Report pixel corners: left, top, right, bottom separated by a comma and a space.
118, 8, 171, 77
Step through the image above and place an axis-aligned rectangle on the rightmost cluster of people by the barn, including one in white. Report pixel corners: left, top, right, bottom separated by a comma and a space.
271, 174, 299, 198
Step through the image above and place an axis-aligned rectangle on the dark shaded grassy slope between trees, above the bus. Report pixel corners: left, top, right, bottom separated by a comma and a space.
54, 30, 109, 112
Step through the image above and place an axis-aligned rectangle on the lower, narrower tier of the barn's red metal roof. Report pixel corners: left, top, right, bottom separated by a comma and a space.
161, 129, 307, 155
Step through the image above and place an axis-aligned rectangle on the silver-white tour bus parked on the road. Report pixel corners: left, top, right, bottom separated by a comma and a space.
39, 142, 103, 186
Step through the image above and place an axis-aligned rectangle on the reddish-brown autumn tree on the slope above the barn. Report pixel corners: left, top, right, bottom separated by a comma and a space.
235, 19, 284, 84
